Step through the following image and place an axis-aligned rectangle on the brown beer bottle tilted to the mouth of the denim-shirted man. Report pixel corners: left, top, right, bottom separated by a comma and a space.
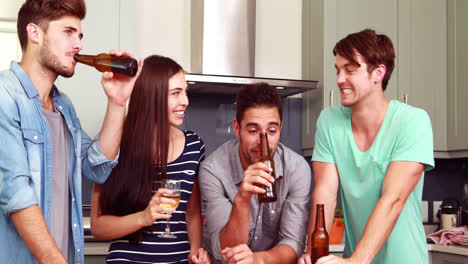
74, 53, 138, 77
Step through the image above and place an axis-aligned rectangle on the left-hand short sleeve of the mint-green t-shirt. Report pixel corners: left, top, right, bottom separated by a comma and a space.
312, 111, 336, 163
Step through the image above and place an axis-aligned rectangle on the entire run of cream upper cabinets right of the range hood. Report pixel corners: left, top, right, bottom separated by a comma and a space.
302, 0, 468, 158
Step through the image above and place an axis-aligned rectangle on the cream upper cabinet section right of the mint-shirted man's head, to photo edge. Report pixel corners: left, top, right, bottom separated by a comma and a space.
398, 0, 468, 158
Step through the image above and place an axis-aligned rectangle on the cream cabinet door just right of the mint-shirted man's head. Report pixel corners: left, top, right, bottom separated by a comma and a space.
397, 0, 447, 154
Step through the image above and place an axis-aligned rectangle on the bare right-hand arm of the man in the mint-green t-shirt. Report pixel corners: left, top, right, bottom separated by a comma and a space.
344, 161, 424, 263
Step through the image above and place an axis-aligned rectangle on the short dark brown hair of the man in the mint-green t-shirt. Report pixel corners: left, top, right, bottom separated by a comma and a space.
333, 29, 395, 91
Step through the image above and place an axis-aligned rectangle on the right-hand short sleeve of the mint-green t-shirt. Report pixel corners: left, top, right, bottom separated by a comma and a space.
392, 109, 434, 171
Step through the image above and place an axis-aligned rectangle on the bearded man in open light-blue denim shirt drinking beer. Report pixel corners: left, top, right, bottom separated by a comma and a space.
0, 0, 142, 264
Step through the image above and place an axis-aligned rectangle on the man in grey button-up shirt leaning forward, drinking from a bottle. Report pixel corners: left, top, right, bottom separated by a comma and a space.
199, 83, 311, 264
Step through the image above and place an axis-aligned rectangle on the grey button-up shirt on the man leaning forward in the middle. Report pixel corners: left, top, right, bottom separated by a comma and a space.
199, 140, 312, 263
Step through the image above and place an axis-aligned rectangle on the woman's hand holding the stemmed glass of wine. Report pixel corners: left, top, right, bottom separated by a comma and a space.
141, 188, 176, 226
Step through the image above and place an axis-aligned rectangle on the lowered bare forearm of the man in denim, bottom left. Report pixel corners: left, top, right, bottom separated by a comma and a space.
10, 205, 67, 263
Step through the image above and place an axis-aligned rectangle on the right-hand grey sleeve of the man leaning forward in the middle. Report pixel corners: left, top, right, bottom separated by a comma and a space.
278, 160, 312, 257
